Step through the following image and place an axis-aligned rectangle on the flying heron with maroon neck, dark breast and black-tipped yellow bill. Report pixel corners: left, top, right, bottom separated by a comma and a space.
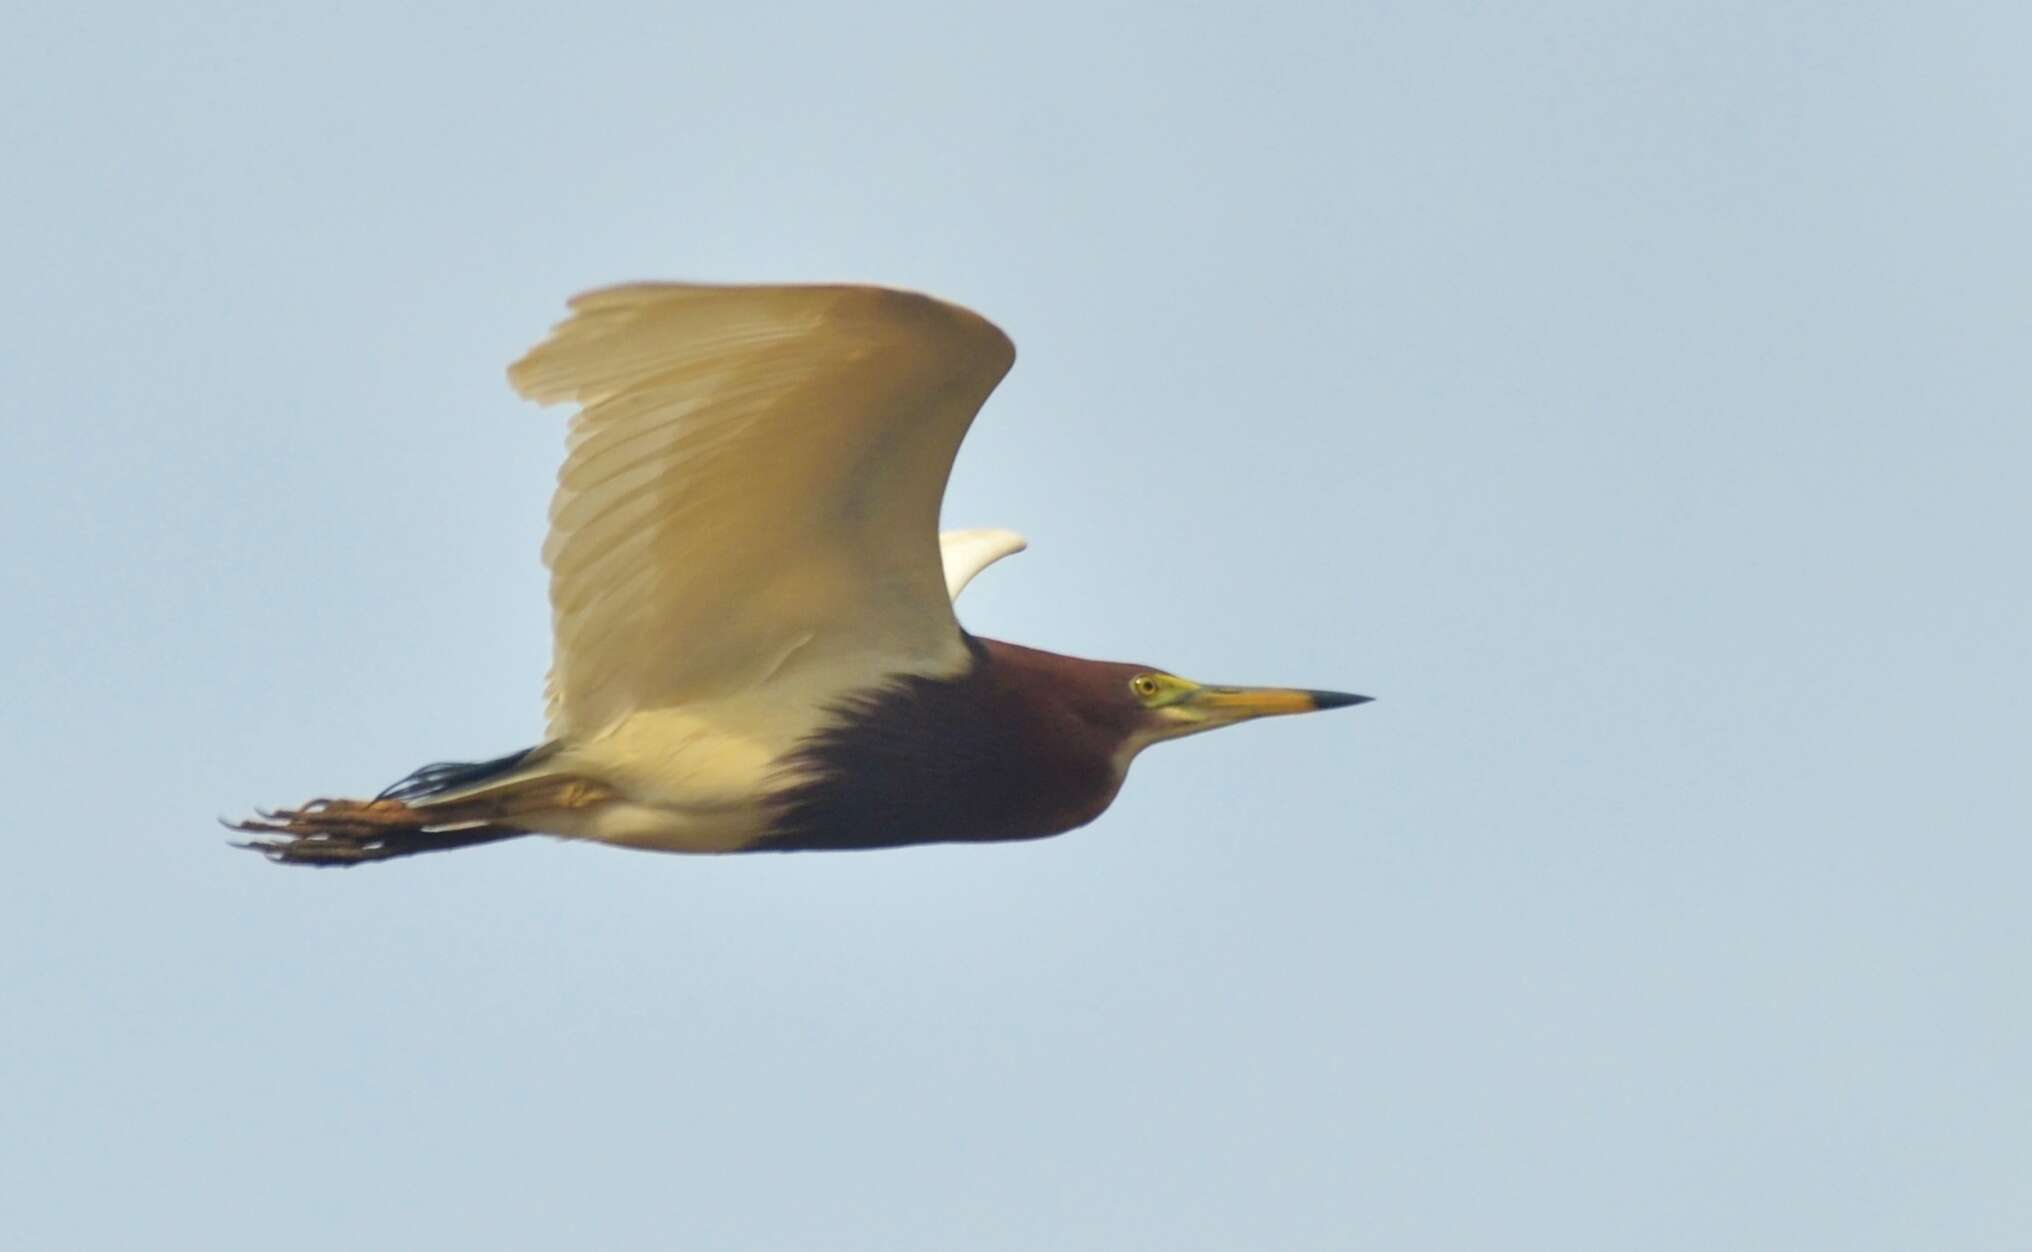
228, 283, 1368, 866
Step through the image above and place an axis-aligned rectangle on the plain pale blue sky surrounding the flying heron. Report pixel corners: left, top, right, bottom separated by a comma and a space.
0, 2, 2032, 1252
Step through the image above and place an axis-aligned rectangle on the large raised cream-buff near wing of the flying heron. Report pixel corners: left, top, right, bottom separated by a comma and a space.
508, 285, 1016, 738
